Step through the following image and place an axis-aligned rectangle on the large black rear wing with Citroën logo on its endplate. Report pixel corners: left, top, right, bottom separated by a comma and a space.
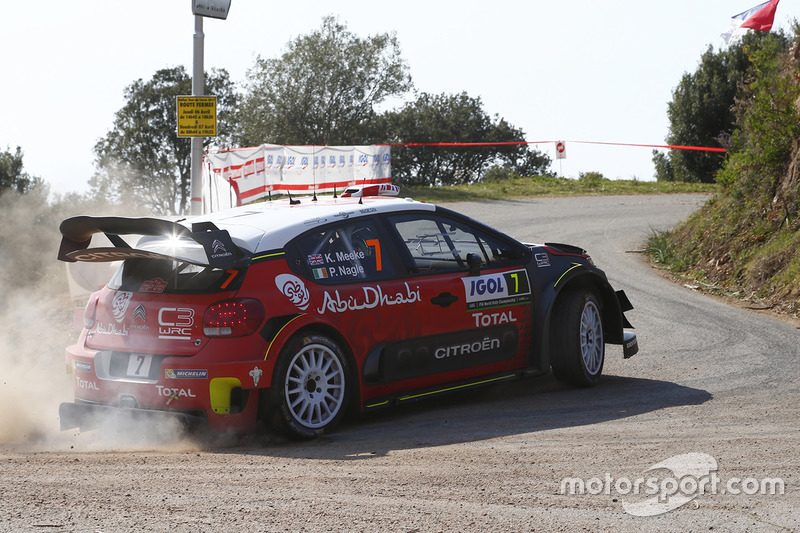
58, 216, 250, 269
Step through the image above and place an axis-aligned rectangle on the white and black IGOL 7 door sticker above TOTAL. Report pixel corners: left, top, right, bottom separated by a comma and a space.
461, 269, 531, 310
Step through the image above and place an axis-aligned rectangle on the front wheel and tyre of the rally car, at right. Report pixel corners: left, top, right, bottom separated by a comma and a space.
550, 289, 605, 387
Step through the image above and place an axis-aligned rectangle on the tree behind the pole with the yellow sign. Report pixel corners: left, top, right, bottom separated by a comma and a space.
89, 67, 238, 214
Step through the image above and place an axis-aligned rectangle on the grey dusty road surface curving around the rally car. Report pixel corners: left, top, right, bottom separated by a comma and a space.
0, 195, 800, 533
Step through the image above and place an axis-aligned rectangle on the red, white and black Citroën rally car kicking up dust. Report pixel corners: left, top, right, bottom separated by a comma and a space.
59, 191, 638, 438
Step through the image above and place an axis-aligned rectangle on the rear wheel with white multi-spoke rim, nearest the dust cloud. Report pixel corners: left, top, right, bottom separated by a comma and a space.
270, 333, 350, 439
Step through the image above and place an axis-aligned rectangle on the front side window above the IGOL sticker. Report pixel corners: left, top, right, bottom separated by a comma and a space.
389, 214, 522, 272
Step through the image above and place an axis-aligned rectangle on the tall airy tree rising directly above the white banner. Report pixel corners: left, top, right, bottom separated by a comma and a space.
237, 16, 411, 146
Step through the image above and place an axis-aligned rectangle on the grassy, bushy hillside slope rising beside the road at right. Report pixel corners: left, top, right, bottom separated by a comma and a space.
649, 27, 800, 316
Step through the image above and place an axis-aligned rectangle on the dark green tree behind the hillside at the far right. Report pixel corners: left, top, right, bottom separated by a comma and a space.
653, 32, 788, 183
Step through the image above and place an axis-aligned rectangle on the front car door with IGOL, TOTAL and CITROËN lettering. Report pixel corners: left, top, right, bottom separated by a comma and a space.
373, 211, 531, 388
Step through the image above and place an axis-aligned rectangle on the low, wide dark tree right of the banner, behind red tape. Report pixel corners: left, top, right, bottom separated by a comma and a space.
383, 92, 550, 185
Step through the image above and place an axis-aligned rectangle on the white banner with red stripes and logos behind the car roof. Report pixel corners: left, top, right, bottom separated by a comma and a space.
203, 144, 392, 212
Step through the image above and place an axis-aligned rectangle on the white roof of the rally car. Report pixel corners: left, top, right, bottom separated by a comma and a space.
190, 196, 436, 254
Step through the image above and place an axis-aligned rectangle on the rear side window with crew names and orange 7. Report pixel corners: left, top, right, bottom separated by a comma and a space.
295, 219, 394, 284
